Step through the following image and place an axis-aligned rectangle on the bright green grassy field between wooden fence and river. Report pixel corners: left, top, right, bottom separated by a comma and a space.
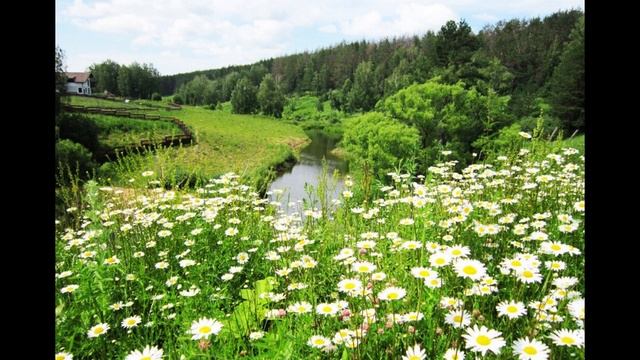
67, 97, 308, 187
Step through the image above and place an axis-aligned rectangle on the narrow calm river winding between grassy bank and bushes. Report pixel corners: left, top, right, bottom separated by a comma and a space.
268, 131, 347, 214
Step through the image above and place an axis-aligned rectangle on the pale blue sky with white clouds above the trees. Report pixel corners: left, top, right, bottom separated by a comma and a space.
56, 0, 585, 75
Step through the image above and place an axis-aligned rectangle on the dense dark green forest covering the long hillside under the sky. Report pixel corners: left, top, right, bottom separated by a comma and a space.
160, 10, 584, 132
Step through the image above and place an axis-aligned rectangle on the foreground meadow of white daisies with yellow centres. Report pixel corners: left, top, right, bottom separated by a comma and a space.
55, 142, 585, 360
